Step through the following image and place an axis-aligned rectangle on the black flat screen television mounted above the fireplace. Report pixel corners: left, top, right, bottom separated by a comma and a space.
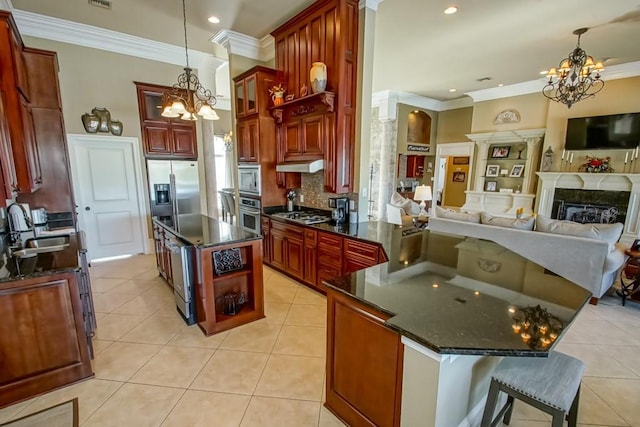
565, 113, 640, 150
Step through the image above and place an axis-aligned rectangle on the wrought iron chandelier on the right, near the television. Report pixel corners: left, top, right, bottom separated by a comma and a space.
542, 28, 604, 108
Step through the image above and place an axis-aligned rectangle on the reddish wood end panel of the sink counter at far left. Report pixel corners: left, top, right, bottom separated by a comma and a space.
0, 273, 93, 407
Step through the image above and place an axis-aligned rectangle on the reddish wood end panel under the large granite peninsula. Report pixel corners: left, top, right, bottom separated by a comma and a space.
325, 289, 404, 427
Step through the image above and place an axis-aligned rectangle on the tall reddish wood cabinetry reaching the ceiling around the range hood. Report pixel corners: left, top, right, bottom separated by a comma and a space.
271, 0, 358, 193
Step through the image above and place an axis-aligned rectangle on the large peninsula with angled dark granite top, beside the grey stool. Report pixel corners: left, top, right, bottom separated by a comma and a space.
325, 226, 590, 427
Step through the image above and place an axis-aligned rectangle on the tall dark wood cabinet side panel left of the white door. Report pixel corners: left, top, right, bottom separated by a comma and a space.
17, 47, 76, 220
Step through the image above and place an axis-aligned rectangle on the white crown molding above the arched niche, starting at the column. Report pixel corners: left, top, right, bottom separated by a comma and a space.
371, 90, 473, 121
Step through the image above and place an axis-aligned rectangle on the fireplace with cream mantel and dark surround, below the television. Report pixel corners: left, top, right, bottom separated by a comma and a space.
536, 172, 640, 245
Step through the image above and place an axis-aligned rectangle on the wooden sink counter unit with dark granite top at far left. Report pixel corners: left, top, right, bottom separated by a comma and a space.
0, 234, 95, 408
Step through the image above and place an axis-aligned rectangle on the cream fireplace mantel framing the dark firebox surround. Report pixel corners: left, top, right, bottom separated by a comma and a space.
536, 172, 640, 245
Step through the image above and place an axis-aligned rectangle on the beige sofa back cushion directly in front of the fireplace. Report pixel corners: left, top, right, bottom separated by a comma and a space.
536, 215, 624, 251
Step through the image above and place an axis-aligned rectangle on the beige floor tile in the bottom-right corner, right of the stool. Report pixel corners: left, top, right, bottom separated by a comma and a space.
583, 377, 640, 426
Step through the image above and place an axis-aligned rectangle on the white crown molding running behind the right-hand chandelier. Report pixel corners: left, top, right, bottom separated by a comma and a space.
466, 61, 640, 102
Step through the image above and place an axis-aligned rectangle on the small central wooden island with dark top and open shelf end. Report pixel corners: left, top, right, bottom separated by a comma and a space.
153, 214, 264, 335
